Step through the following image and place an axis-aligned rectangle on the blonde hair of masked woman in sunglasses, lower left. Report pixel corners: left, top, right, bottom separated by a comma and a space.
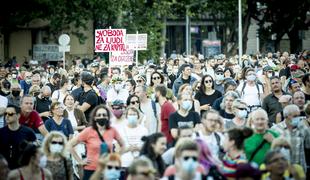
42, 131, 67, 158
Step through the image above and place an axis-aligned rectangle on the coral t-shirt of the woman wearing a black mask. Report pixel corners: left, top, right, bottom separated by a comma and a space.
78, 127, 121, 170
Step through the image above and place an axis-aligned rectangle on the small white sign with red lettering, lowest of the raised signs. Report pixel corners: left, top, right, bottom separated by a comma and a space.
109, 50, 134, 66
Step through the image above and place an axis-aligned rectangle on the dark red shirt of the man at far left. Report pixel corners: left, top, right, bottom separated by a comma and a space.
19, 110, 44, 129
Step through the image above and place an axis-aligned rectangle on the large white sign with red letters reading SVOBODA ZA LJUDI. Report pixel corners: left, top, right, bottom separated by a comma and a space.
95, 29, 126, 52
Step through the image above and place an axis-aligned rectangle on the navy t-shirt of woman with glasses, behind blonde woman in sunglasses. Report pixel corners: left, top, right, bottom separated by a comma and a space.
45, 118, 74, 137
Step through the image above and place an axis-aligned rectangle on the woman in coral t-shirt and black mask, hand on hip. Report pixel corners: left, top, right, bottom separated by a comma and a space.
68, 105, 124, 180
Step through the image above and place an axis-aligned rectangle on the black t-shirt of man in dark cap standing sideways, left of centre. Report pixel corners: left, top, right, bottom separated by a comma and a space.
79, 89, 98, 120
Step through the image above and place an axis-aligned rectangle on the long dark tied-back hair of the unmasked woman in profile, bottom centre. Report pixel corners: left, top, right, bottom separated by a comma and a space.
140, 133, 166, 176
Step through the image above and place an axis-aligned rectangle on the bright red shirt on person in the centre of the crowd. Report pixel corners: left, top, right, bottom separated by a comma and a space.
160, 101, 175, 143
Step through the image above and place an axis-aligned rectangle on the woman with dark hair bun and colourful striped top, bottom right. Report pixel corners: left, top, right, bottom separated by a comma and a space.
222, 127, 253, 179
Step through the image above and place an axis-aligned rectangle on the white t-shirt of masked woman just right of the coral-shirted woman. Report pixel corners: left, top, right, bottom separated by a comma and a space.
119, 125, 148, 167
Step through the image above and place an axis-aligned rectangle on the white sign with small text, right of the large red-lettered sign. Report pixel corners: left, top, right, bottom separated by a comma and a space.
126, 34, 147, 50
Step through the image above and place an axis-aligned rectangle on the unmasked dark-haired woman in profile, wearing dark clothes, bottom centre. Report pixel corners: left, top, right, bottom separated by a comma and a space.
140, 133, 167, 178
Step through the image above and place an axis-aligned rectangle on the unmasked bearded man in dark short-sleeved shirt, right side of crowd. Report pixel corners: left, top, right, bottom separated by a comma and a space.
262, 76, 286, 125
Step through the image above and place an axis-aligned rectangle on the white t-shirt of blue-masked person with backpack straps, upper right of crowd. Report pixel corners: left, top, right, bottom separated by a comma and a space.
237, 82, 263, 106
